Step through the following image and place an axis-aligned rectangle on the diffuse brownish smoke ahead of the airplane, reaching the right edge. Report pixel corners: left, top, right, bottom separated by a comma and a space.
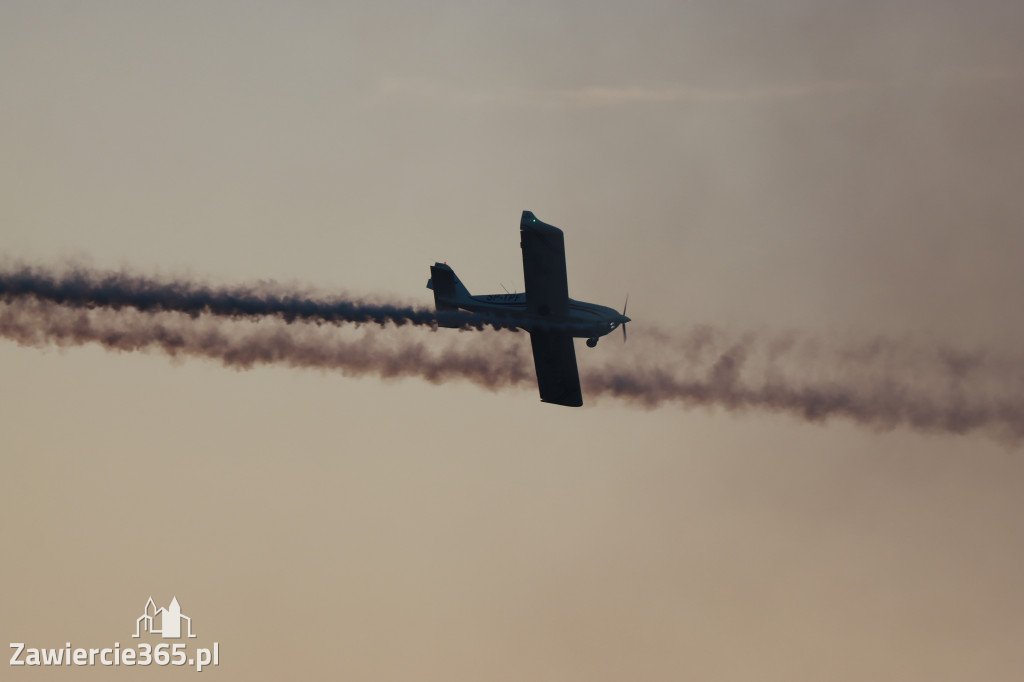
582, 328, 1024, 441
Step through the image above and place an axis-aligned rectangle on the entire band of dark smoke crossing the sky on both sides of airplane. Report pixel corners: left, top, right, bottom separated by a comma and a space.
0, 268, 1024, 442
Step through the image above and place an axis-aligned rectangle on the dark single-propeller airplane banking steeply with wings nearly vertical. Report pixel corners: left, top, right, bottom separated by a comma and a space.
427, 211, 630, 408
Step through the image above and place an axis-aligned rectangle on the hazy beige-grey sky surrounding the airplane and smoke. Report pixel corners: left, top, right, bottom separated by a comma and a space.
0, 0, 1024, 682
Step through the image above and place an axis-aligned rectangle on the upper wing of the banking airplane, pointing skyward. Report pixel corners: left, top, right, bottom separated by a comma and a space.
519, 211, 569, 321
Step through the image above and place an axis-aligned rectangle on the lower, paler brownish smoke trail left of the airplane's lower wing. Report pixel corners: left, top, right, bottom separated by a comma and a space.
0, 298, 534, 390
